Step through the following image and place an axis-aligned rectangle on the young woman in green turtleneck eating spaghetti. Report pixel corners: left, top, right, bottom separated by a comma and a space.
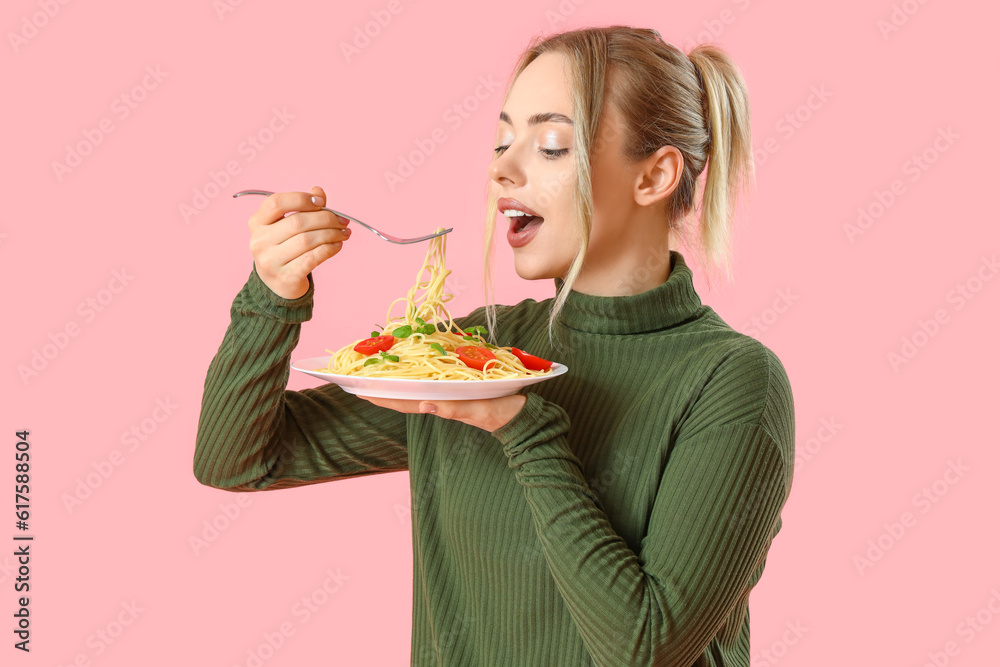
194, 26, 794, 667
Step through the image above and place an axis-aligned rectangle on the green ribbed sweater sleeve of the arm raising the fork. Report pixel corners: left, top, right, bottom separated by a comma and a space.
194, 268, 408, 491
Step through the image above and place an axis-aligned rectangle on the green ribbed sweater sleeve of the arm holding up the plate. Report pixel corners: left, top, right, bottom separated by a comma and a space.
493, 345, 794, 667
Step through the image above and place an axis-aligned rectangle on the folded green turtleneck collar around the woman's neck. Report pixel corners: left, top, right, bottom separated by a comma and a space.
553, 250, 702, 334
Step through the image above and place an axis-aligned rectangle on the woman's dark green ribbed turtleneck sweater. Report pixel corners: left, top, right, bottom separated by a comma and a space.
194, 251, 794, 667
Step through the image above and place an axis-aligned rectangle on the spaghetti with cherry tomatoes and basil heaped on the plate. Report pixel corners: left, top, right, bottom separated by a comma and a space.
317, 227, 553, 380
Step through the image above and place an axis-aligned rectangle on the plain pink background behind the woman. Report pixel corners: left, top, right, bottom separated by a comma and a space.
0, 0, 1000, 667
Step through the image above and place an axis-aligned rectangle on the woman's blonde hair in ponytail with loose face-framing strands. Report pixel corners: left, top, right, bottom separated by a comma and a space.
483, 25, 754, 352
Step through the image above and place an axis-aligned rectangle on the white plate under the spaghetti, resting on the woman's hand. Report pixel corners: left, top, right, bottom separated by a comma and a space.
292, 355, 569, 401
